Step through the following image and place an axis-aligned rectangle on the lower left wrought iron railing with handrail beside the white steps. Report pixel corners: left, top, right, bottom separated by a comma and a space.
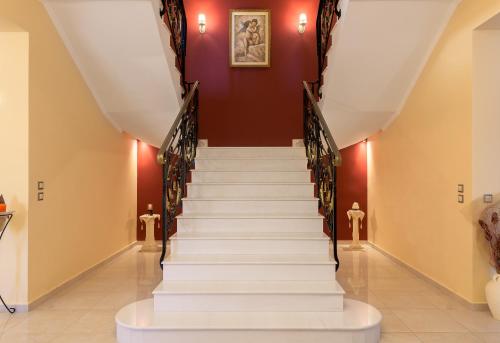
157, 81, 199, 268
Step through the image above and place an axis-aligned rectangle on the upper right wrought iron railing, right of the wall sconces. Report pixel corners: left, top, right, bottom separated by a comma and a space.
316, 0, 342, 87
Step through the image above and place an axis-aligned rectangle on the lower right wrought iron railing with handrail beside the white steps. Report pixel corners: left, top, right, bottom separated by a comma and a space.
303, 81, 342, 269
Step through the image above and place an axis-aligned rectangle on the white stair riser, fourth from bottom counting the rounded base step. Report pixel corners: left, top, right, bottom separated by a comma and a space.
170, 239, 329, 256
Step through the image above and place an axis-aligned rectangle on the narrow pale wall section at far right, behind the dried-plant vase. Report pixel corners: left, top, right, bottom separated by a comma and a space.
471, 25, 500, 294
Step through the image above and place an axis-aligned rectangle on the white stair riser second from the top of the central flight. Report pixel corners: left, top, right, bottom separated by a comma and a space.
195, 159, 307, 171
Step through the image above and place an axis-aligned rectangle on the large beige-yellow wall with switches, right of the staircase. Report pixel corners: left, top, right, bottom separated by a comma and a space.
368, 0, 500, 303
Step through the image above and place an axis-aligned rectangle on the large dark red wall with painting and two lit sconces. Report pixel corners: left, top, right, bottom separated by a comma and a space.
184, 0, 319, 146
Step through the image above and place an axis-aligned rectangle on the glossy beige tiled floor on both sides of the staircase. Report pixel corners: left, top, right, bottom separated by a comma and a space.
0, 243, 500, 343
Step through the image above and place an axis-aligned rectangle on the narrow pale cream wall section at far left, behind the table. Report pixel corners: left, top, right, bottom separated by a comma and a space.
0, 29, 29, 311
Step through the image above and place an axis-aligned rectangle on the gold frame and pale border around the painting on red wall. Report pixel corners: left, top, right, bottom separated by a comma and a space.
229, 9, 271, 68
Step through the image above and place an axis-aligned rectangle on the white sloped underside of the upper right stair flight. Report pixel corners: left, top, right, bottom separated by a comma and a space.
320, 0, 458, 148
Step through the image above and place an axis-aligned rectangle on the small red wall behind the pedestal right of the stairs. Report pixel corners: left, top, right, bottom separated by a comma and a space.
337, 142, 368, 240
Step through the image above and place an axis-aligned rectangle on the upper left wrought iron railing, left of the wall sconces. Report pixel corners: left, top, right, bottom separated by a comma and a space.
160, 0, 188, 97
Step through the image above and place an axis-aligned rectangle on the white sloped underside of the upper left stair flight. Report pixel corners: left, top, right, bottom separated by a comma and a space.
43, 0, 180, 146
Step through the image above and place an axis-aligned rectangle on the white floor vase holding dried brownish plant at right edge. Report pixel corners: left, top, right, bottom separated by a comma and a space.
479, 203, 500, 320
